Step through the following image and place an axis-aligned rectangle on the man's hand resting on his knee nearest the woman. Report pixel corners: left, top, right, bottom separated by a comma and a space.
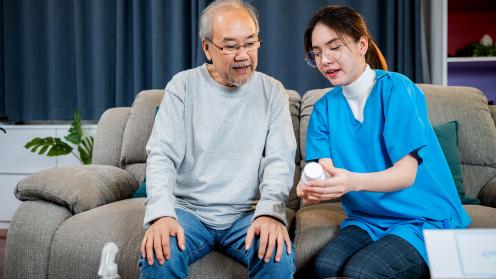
245, 216, 291, 263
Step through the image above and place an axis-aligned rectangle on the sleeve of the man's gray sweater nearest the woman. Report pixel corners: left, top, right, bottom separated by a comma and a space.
253, 83, 296, 228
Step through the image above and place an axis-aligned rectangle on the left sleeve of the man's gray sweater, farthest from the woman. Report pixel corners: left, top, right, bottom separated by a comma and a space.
144, 79, 185, 229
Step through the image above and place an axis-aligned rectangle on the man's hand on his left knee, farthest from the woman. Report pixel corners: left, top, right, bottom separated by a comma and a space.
141, 217, 186, 265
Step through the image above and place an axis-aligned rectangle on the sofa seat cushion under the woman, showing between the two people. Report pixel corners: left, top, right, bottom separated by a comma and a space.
294, 203, 346, 274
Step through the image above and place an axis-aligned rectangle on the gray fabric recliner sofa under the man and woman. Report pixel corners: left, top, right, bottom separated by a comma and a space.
5, 85, 496, 278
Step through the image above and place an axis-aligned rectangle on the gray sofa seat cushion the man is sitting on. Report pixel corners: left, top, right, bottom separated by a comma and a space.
48, 198, 294, 278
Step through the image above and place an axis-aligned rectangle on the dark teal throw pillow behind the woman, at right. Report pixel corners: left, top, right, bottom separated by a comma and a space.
434, 121, 480, 204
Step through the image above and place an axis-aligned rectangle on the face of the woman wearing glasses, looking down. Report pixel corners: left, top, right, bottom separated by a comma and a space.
312, 23, 368, 86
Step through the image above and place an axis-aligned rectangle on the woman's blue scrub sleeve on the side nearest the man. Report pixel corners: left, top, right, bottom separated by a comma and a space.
306, 97, 331, 161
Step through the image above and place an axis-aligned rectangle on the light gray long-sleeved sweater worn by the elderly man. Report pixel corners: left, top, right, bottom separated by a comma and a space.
144, 64, 296, 229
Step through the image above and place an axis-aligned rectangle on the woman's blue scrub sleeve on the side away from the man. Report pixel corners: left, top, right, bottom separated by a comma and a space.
383, 78, 430, 165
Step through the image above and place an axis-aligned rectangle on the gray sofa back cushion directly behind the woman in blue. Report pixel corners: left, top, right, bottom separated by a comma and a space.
300, 84, 496, 200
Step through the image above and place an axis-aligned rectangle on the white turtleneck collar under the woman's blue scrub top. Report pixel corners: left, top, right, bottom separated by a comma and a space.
342, 65, 375, 123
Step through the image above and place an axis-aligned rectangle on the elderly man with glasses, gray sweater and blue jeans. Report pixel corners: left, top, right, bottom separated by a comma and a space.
140, 0, 296, 278
